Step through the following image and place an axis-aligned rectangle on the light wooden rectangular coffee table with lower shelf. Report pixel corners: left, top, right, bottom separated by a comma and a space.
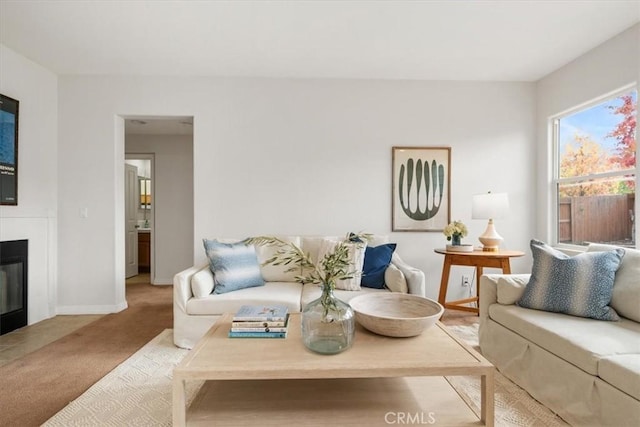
173, 313, 495, 426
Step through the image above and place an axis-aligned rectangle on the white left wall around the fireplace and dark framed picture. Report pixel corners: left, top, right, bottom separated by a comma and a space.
0, 45, 58, 324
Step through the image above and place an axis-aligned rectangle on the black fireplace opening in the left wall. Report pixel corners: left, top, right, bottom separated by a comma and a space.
0, 240, 29, 335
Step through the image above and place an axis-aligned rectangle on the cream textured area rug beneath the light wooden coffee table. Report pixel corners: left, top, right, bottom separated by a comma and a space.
44, 325, 567, 427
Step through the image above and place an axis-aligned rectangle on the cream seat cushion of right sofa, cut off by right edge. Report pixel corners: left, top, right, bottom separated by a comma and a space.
598, 354, 640, 400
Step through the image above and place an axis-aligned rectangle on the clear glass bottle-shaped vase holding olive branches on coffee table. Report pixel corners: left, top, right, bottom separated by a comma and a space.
302, 284, 356, 354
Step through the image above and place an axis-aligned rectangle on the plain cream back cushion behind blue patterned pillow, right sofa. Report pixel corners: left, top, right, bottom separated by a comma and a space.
587, 243, 640, 322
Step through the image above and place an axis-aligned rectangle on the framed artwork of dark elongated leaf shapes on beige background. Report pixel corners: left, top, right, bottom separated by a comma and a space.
391, 147, 451, 231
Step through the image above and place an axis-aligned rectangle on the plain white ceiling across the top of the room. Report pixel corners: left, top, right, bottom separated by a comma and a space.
0, 0, 640, 81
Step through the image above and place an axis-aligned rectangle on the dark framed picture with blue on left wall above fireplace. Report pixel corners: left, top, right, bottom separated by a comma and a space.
0, 94, 19, 205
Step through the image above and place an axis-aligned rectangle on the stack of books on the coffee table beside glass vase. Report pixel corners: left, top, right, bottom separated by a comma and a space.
229, 305, 289, 338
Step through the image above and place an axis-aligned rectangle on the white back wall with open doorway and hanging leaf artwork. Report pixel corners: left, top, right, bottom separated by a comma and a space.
59, 76, 535, 309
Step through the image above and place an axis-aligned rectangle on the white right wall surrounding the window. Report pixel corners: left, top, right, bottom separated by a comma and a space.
536, 24, 640, 241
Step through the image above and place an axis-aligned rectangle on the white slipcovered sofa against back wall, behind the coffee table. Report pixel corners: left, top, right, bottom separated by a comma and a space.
173, 236, 425, 349
